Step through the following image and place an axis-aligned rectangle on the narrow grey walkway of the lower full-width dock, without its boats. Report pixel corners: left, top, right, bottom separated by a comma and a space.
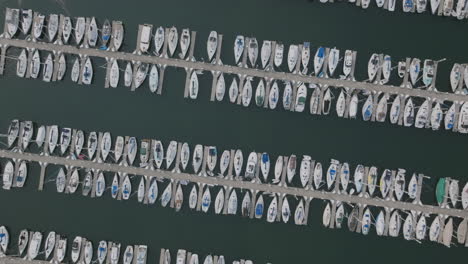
0, 150, 468, 218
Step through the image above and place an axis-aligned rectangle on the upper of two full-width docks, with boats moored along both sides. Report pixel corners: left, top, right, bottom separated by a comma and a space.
0, 9, 468, 133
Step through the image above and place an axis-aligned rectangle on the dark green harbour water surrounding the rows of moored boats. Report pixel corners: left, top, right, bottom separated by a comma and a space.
0, 0, 468, 263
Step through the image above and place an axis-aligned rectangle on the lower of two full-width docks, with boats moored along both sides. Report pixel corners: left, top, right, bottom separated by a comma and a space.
0, 120, 468, 247
